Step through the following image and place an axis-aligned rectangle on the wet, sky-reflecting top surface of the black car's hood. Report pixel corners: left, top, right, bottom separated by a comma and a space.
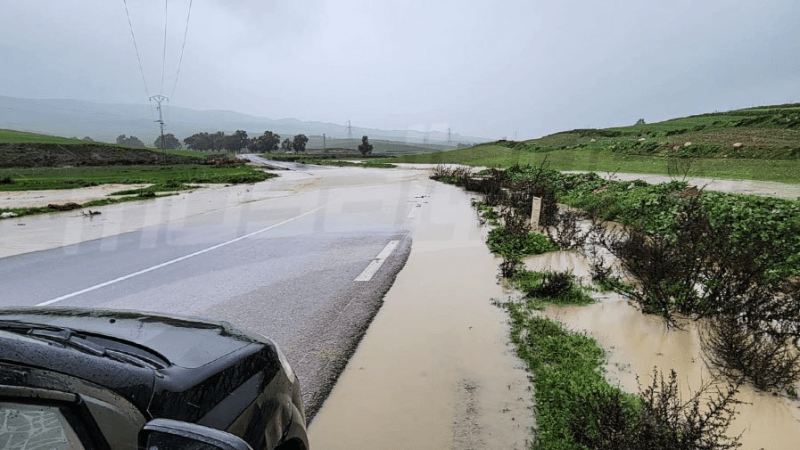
0, 307, 264, 369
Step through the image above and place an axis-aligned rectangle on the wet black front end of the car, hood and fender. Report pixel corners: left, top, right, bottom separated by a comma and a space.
0, 308, 308, 449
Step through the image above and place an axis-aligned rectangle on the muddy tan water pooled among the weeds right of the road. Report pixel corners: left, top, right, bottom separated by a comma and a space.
525, 252, 800, 449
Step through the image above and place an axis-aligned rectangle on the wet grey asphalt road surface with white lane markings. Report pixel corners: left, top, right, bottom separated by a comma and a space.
0, 164, 432, 416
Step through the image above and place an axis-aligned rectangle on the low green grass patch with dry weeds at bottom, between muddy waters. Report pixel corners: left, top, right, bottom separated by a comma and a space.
505, 298, 739, 450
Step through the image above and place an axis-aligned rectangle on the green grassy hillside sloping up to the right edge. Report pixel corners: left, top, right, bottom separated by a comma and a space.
392, 105, 800, 183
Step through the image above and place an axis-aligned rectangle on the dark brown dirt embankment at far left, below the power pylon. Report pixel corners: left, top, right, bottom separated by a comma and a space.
0, 143, 205, 167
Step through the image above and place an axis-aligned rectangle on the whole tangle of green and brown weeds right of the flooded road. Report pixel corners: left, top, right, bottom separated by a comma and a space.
432, 157, 800, 449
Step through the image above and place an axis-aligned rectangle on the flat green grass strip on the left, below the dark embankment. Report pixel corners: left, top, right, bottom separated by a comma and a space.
0, 164, 276, 191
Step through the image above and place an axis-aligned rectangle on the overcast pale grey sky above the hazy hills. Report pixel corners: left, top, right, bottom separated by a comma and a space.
0, 0, 800, 139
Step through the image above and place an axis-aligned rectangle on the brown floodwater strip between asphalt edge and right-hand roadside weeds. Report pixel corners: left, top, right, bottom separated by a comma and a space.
309, 180, 533, 450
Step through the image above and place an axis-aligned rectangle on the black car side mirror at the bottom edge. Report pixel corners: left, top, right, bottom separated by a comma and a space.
139, 419, 253, 450
